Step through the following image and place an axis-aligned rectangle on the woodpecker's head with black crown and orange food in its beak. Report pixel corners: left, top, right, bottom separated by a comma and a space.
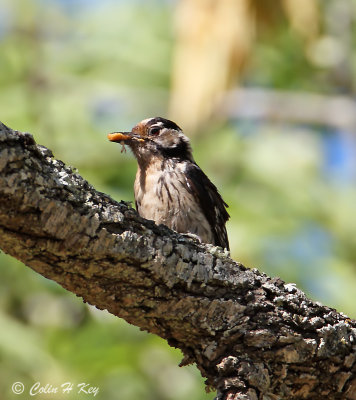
108, 117, 194, 164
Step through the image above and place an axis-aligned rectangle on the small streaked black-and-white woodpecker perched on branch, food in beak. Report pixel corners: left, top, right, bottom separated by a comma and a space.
108, 117, 229, 250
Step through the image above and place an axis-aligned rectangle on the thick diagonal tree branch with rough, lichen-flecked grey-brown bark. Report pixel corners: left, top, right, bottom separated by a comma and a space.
0, 124, 356, 400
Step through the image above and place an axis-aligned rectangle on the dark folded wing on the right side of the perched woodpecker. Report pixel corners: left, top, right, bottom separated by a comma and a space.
186, 163, 230, 250
